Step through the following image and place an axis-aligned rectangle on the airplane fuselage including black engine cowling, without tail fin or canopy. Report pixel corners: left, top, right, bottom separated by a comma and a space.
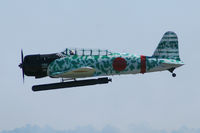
19, 50, 183, 78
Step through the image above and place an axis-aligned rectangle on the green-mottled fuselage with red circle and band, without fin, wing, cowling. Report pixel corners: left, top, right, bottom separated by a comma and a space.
47, 53, 183, 78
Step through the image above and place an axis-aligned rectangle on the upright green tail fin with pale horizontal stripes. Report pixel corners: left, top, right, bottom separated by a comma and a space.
153, 31, 180, 61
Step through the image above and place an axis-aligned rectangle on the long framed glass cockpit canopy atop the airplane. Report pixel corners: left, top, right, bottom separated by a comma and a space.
61, 48, 112, 56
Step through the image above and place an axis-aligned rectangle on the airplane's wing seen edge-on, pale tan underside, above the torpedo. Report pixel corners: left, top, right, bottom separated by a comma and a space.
50, 67, 95, 78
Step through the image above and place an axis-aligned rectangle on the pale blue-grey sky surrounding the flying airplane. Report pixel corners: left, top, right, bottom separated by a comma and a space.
0, 0, 200, 132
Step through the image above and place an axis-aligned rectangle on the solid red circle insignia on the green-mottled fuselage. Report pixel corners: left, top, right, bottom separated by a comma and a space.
113, 57, 127, 71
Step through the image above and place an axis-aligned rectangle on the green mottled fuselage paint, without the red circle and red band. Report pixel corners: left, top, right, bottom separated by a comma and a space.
48, 54, 182, 77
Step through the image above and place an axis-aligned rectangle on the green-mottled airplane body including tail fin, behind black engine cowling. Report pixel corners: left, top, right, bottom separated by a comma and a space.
47, 31, 183, 78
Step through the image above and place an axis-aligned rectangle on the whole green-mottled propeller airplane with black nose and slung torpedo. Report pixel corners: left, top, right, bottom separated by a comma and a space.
19, 31, 184, 91
